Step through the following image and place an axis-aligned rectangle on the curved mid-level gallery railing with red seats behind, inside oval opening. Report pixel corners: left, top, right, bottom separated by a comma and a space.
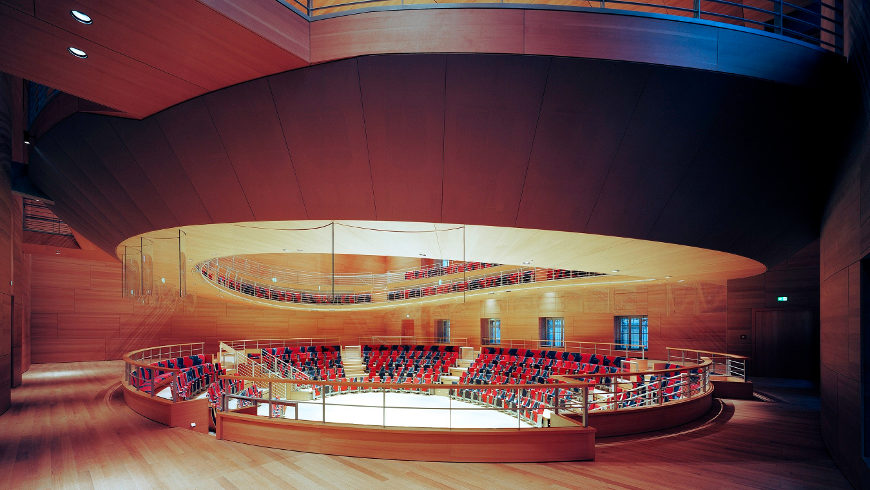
196, 257, 605, 305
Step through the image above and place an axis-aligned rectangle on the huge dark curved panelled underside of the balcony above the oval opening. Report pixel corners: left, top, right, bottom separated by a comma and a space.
30, 54, 837, 265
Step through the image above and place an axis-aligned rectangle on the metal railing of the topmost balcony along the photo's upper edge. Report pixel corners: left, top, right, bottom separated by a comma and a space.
278, 0, 843, 53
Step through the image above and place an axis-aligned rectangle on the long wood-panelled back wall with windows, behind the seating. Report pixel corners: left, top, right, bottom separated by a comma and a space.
31, 249, 811, 376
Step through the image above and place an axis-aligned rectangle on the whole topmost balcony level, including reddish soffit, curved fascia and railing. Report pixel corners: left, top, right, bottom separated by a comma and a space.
0, 0, 843, 118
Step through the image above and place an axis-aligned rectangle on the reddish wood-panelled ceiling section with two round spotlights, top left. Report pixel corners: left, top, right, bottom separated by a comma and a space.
0, 0, 308, 118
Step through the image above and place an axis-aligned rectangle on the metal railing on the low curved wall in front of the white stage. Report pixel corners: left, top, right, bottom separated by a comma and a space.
219, 359, 712, 429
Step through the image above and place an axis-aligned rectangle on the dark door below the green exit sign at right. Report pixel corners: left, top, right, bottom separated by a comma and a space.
750, 309, 819, 380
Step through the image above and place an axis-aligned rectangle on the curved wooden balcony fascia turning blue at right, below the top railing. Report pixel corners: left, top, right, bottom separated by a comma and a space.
310, 8, 834, 85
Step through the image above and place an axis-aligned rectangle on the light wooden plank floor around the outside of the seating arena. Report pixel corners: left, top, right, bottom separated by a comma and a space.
0, 361, 848, 489
